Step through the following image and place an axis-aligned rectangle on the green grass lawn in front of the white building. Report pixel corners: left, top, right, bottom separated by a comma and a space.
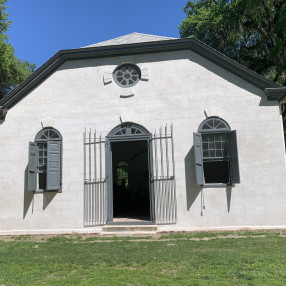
0, 231, 286, 286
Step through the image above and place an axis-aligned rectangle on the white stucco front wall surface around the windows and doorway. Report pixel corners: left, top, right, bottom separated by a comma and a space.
0, 48, 286, 233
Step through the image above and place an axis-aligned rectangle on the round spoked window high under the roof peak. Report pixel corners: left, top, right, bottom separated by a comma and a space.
113, 64, 141, 87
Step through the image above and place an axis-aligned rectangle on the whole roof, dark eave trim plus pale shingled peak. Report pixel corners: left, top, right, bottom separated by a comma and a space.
0, 33, 286, 111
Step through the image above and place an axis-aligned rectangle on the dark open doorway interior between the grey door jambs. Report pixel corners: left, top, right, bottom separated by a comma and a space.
111, 140, 150, 221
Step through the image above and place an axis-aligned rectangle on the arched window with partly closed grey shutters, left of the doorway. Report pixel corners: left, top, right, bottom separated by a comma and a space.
28, 128, 62, 191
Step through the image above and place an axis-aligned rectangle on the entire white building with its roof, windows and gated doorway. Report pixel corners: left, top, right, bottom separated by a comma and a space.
0, 33, 286, 234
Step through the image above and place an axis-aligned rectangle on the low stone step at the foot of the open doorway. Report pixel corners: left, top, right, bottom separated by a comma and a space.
101, 225, 158, 236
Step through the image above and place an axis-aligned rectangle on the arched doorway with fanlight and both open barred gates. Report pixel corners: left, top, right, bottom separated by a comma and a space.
84, 123, 176, 226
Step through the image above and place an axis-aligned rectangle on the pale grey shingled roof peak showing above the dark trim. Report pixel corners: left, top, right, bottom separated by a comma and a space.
84, 32, 176, 48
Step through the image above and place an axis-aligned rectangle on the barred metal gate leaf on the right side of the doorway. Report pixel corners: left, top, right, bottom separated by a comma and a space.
151, 125, 177, 224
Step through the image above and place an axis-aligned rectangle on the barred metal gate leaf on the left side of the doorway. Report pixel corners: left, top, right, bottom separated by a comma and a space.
83, 130, 107, 226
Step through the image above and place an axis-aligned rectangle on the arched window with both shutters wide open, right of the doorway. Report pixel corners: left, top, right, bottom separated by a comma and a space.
194, 117, 240, 187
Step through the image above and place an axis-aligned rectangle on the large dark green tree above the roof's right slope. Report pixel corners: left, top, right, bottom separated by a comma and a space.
179, 0, 286, 85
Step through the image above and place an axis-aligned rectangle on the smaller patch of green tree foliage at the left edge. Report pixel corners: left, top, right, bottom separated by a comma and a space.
0, 0, 35, 99
